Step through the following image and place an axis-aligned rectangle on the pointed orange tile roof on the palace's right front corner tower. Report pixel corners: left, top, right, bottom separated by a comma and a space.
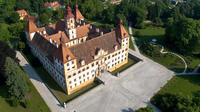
115, 19, 130, 39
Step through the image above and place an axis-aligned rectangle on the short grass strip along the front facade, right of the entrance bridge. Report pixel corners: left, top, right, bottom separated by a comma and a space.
112, 57, 137, 75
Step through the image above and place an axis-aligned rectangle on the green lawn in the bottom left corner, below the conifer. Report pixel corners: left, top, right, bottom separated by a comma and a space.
0, 69, 50, 112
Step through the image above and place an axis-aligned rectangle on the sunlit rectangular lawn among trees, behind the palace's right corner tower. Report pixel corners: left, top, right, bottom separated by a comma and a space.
133, 26, 165, 43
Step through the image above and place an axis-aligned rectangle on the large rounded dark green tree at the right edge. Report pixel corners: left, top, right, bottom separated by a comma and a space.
166, 17, 200, 53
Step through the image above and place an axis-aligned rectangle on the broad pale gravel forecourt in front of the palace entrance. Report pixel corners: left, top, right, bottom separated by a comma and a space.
67, 50, 174, 112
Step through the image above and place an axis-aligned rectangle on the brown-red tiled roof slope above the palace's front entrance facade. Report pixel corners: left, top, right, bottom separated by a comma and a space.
69, 31, 120, 67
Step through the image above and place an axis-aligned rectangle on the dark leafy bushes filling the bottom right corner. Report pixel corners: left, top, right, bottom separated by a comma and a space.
151, 94, 200, 112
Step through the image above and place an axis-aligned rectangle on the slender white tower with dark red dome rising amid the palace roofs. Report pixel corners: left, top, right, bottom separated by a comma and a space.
65, 6, 76, 40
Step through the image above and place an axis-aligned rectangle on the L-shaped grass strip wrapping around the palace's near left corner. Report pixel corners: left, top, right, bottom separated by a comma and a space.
23, 54, 100, 103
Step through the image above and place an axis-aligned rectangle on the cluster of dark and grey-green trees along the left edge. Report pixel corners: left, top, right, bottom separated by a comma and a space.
0, 41, 29, 107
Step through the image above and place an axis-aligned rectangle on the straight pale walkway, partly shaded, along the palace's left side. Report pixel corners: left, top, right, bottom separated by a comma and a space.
16, 51, 66, 112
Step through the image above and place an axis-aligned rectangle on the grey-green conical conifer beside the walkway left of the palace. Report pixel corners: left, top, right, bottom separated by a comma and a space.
4, 57, 29, 100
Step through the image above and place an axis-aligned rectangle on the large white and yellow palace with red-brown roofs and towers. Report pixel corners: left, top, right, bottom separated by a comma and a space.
26, 5, 129, 94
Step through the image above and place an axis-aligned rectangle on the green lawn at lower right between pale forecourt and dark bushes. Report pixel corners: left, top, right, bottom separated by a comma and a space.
157, 75, 200, 97
